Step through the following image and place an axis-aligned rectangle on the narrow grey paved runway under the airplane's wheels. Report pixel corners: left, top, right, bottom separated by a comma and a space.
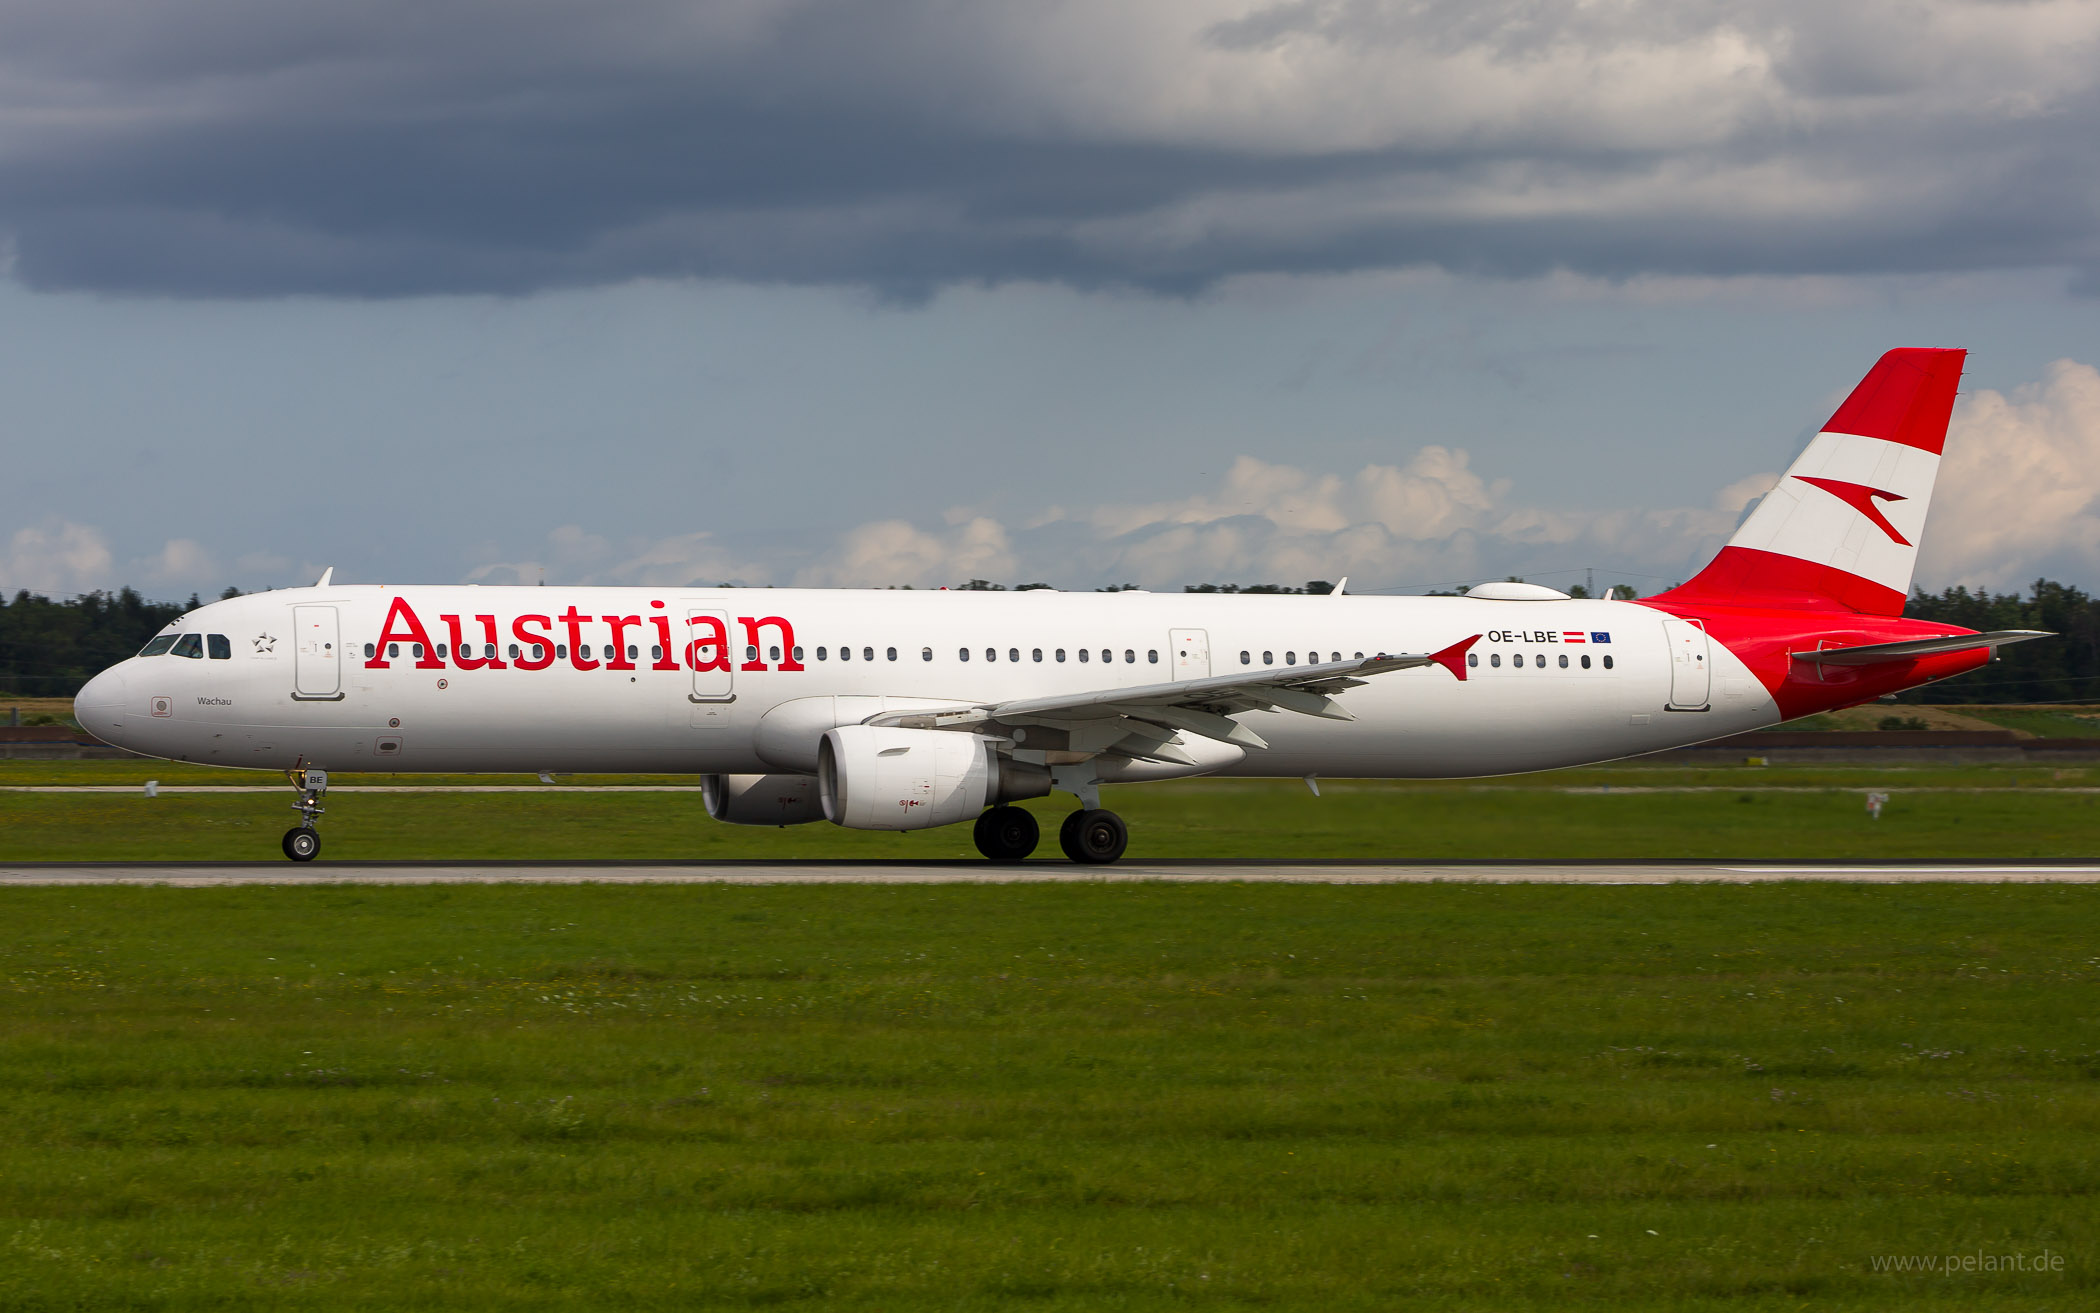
0, 861, 2100, 887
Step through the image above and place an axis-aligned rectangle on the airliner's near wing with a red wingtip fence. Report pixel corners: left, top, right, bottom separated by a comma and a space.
872, 634, 1481, 765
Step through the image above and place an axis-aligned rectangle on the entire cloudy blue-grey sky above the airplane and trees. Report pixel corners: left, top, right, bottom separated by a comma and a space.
0, 0, 2100, 597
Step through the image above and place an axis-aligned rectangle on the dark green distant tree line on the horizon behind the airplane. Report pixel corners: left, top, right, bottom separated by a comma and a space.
12, 580, 2100, 702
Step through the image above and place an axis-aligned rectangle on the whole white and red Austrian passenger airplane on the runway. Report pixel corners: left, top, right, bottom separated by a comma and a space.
74, 349, 2050, 863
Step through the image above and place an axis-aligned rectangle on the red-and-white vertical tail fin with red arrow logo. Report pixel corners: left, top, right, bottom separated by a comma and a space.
1659, 347, 1968, 616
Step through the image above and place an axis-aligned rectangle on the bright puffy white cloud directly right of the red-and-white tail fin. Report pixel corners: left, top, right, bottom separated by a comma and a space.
1917, 359, 2100, 588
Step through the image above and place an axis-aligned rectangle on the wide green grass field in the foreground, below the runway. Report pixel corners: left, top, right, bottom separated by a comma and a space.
0, 884, 2100, 1311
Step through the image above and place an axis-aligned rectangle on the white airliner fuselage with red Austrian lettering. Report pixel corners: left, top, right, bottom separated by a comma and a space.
78, 586, 1781, 777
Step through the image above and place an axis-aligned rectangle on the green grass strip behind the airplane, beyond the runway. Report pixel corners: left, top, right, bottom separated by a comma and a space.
12, 760, 2100, 863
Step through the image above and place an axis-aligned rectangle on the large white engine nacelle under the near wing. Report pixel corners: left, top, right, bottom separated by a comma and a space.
817, 725, 1050, 830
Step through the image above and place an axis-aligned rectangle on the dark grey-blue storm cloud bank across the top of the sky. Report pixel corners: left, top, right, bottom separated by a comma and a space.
0, 0, 2100, 296
